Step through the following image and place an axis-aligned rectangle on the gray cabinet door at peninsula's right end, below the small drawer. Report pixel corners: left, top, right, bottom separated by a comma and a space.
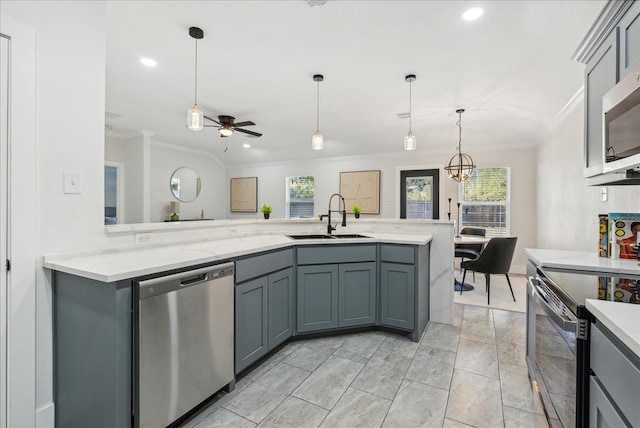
380, 262, 416, 330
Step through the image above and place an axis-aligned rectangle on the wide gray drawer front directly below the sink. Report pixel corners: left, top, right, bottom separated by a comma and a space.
297, 245, 376, 265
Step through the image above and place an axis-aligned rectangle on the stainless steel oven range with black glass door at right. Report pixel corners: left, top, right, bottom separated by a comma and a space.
526, 266, 640, 428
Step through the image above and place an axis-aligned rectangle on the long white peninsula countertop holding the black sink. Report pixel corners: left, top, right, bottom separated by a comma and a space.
43, 232, 432, 282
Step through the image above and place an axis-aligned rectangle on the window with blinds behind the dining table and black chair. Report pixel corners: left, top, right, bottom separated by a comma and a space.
458, 168, 510, 237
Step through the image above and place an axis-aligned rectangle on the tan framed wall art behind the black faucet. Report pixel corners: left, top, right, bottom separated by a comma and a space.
340, 170, 380, 214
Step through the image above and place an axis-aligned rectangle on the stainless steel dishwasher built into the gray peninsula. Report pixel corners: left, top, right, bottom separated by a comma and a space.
136, 263, 234, 428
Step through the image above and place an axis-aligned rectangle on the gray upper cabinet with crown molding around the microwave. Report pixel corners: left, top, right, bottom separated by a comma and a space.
574, 0, 640, 185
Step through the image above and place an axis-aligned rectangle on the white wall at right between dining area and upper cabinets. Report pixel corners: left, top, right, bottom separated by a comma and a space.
536, 95, 640, 252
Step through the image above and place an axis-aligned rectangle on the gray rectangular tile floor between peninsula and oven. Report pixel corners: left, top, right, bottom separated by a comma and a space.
183, 304, 547, 428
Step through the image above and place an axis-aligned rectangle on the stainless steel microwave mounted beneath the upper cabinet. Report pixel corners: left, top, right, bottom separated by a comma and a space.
602, 65, 640, 172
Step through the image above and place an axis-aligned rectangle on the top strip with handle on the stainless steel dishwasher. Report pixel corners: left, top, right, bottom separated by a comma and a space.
136, 262, 234, 300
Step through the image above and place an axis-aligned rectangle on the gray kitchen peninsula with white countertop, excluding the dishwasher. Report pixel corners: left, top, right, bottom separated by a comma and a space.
44, 222, 453, 426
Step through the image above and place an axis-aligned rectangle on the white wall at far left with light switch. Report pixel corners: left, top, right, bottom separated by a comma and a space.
2, 1, 106, 426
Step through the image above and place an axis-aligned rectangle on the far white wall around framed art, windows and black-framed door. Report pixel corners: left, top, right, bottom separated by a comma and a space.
226, 148, 537, 272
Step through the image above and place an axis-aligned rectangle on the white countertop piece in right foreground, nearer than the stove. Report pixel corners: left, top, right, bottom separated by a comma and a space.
586, 299, 640, 357
